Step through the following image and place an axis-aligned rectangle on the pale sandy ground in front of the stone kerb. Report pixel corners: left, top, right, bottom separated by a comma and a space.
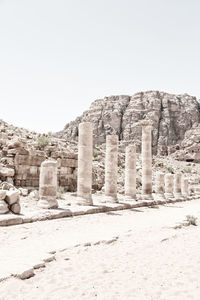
0, 200, 200, 300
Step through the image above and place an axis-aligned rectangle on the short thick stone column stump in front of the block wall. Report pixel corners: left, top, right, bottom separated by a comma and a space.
38, 159, 58, 209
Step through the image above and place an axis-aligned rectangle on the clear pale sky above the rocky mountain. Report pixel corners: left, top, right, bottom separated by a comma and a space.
0, 0, 200, 132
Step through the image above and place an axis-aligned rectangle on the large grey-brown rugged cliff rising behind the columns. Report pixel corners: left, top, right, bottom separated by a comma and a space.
57, 91, 200, 155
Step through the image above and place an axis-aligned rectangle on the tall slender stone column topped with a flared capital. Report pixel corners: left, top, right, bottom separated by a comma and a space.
141, 120, 153, 200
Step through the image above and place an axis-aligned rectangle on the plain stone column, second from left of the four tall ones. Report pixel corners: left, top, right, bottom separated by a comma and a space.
105, 135, 118, 203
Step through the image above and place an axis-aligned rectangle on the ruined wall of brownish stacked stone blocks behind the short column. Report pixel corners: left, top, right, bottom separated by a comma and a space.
0, 139, 78, 192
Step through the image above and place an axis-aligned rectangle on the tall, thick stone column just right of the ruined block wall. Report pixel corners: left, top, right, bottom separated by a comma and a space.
75, 122, 93, 205
